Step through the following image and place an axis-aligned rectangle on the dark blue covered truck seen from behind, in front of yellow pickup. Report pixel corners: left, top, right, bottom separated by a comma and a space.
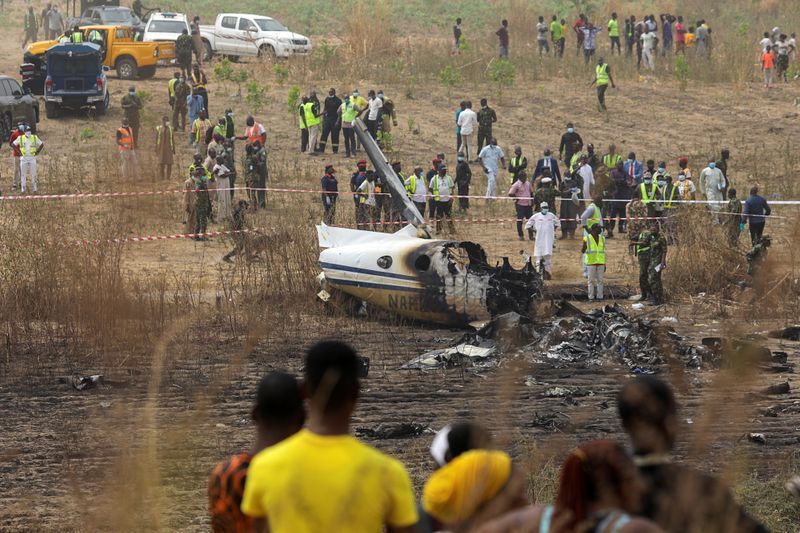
44, 43, 109, 118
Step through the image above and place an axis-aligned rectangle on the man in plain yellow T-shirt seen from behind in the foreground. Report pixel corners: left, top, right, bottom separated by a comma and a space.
242, 341, 418, 533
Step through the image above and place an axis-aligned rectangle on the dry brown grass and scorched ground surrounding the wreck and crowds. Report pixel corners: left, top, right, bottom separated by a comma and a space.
0, 2, 800, 532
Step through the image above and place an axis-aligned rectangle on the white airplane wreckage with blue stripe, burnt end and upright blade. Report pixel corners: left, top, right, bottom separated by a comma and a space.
317, 119, 543, 326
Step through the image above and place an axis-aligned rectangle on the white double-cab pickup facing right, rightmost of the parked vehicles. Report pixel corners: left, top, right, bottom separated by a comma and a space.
200, 13, 311, 59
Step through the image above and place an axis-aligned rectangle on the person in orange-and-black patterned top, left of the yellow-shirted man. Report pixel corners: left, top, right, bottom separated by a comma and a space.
208, 372, 305, 533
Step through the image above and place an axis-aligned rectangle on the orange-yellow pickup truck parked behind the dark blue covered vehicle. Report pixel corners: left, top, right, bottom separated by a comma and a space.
23, 25, 175, 80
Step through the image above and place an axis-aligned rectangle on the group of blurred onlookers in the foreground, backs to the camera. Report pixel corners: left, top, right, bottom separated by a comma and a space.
208, 341, 766, 533
